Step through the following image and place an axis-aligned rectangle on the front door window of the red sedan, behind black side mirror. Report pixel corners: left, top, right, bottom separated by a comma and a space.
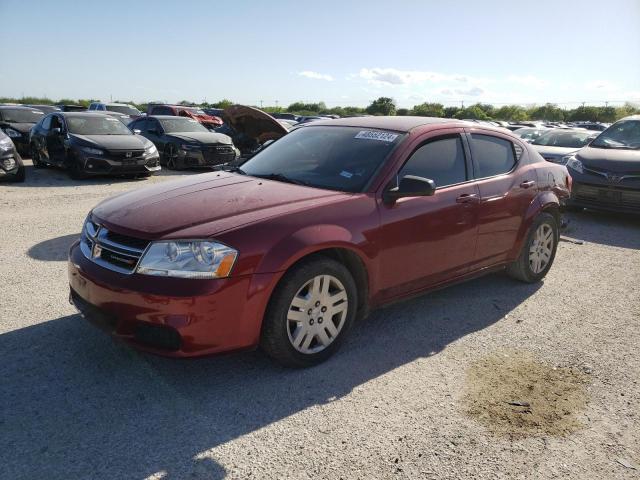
400, 135, 467, 187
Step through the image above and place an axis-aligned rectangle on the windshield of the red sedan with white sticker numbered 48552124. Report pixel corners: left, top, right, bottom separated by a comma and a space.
241, 126, 403, 192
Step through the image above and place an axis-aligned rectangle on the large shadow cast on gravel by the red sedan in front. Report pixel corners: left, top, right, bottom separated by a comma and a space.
0, 275, 540, 480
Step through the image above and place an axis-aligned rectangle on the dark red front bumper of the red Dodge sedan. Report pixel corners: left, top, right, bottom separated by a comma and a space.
68, 242, 276, 357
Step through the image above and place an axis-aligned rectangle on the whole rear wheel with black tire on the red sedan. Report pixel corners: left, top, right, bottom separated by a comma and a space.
507, 212, 560, 283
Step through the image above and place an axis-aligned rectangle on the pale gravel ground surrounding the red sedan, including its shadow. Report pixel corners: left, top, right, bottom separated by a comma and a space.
0, 161, 640, 480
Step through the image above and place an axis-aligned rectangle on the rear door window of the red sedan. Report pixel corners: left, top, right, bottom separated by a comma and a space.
471, 133, 516, 178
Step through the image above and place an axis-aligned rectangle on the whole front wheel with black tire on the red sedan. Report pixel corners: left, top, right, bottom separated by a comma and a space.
260, 256, 358, 368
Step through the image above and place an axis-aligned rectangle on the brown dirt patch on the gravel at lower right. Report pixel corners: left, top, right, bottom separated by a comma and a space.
463, 350, 588, 436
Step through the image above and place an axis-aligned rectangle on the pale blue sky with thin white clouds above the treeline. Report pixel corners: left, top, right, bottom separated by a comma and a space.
0, 0, 640, 106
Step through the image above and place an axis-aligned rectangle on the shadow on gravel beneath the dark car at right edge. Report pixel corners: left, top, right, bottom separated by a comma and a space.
563, 210, 640, 250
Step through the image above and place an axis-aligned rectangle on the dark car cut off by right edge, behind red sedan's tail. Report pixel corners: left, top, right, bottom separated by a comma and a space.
566, 115, 640, 213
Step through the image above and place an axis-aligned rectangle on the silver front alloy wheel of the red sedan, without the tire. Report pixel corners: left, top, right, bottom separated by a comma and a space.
287, 275, 349, 354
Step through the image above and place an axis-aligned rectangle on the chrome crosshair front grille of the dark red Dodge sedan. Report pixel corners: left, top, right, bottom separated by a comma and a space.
80, 221, 150, 274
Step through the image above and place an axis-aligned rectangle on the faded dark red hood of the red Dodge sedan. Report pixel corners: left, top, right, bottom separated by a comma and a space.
93, 172, 349, 240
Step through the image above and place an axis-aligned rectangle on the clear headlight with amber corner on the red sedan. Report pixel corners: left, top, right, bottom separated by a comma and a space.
137, 240, 238, 279
